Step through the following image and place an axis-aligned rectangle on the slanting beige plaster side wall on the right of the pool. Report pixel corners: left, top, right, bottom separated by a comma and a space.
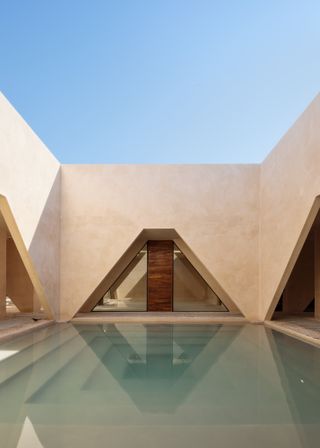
259, 96, 320, 319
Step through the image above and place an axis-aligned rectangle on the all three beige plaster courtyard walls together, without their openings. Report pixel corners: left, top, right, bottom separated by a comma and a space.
0, 94, 320, 320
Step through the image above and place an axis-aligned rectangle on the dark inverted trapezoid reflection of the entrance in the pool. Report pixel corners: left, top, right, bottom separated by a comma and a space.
80, 325, 240, 412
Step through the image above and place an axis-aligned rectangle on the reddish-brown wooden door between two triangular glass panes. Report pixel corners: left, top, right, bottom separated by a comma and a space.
148, 241, 173, 311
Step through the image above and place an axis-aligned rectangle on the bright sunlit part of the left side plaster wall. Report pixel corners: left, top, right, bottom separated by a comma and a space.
0, 93, 60, 248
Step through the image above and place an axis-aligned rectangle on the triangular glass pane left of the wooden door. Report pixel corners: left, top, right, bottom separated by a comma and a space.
92, 246, 147, 311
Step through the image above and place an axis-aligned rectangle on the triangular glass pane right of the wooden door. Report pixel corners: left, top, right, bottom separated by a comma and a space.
173, 245, 228, 311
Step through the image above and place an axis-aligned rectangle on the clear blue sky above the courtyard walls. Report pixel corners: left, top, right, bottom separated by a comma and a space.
0, 0, 320, 163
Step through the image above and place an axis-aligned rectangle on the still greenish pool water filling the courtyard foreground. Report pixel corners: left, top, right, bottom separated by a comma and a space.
0, 324, 320, 448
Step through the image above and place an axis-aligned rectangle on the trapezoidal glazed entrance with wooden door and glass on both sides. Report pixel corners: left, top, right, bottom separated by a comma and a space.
91, 240, 228, 312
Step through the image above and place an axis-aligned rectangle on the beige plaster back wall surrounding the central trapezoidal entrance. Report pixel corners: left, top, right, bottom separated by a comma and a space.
60, 165, 260, 319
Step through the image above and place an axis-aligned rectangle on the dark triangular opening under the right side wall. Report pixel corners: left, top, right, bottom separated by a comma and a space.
273, 208, 320, 319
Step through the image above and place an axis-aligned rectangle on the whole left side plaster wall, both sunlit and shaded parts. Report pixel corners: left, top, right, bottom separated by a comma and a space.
0, 93, 60, 312
